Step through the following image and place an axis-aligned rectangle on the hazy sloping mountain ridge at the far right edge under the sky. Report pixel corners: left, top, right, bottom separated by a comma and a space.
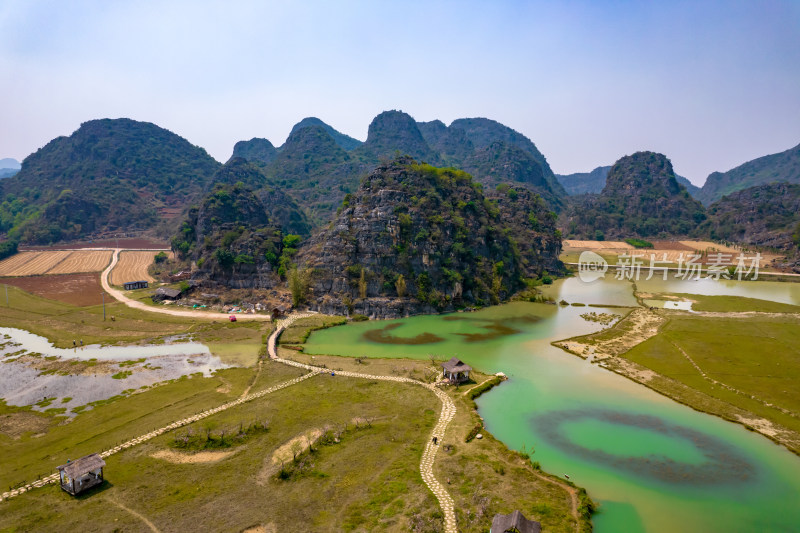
698, 144, 800, 205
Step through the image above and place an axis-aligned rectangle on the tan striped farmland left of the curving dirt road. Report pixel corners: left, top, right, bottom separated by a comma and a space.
0, 250, 111, 276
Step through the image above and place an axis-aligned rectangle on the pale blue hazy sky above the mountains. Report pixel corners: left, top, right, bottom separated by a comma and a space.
0, 0, 800, 185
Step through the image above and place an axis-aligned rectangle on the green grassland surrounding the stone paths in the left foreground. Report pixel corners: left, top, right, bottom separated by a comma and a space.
0, 290, 591, 532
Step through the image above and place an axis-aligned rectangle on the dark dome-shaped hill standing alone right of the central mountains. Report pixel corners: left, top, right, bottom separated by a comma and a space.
560, 152, 706, 240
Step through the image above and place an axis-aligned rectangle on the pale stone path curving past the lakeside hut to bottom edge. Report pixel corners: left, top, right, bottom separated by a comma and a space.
267, 313, 458, 533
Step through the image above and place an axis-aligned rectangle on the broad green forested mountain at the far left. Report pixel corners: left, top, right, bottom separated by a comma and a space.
0, 119, 219, 244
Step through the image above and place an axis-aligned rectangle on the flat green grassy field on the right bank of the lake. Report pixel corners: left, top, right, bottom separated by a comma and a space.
624, 316, 800, 451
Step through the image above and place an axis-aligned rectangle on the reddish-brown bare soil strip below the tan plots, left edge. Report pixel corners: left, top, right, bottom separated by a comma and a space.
0, 272, 104, 307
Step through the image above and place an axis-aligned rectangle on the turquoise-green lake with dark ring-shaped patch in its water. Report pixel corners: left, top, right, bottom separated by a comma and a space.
306, 278, 800, 533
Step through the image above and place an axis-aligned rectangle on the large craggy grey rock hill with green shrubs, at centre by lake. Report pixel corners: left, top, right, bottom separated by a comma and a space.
298, 158, 558, 317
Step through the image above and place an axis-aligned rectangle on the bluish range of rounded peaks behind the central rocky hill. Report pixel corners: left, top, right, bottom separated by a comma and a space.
234, 110, 566, 226
